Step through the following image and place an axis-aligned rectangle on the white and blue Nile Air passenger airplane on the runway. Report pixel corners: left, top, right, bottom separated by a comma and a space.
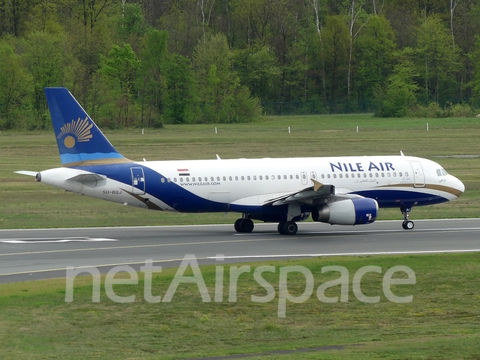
16, 88, 465, 235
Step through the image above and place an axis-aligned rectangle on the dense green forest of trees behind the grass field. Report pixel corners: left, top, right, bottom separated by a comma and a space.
0, 0, 480, 129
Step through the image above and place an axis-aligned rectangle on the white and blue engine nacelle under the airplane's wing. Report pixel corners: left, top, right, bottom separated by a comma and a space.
312, 198, 378, 225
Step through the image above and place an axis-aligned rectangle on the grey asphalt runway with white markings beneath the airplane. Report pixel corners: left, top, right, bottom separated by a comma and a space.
0, 219, 480, 283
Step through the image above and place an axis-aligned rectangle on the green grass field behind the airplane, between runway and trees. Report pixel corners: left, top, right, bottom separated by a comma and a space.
0, 115, 480, 228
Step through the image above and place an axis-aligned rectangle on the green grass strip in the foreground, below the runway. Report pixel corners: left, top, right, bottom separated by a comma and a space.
0, 254, 480, 359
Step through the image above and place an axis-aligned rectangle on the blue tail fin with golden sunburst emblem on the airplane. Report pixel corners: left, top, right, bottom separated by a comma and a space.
45, 88, 128, 166
